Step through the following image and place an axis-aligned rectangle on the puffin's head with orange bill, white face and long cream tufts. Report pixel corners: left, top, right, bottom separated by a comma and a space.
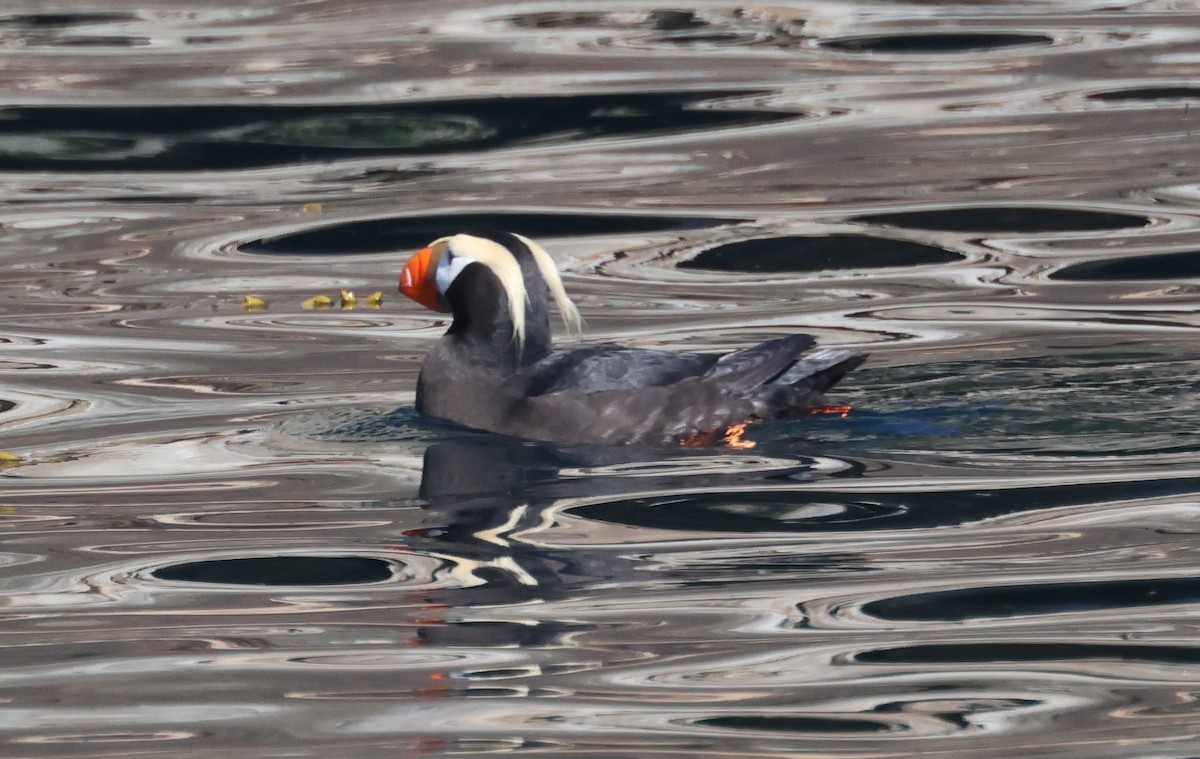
400, 233, 581, 348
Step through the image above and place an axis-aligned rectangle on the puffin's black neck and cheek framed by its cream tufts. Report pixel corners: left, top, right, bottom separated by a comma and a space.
445, 263, 551, 371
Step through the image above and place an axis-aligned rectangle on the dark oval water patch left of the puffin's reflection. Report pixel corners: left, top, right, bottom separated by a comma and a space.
154, 556, 394, 586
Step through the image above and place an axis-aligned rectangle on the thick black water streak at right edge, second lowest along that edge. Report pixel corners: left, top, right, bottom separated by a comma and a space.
863, 578, 1200, 622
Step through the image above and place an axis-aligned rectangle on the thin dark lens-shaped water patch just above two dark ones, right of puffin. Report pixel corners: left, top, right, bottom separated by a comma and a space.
854, 207, 1150, 233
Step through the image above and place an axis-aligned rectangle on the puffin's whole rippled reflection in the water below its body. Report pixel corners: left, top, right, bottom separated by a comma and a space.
406, 432, 862, 730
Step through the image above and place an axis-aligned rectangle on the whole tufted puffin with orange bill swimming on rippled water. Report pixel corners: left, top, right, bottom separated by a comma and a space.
400, 232, 866, 444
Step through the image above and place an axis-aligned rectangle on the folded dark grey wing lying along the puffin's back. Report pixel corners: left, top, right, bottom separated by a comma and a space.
524, 345, 719, 395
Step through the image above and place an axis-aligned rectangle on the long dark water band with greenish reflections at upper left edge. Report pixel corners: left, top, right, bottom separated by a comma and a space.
0, 90, 802, 172
